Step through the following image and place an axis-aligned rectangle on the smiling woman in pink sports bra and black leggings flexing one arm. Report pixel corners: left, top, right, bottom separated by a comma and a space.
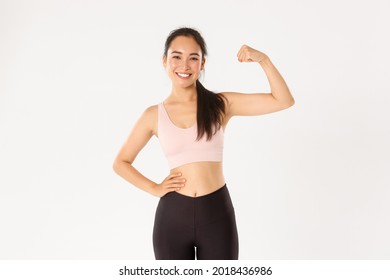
114, 28, 294, 259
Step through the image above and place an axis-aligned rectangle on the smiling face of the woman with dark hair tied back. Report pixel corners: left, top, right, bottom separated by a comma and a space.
163, 36, 205, 87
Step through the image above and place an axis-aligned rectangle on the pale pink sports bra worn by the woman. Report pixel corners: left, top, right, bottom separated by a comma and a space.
157, 102, 224, 169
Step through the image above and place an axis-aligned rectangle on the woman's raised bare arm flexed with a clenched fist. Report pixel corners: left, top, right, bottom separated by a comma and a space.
222, 45, 295, 119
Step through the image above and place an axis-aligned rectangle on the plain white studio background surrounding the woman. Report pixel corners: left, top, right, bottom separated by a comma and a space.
0, 0, 390, 259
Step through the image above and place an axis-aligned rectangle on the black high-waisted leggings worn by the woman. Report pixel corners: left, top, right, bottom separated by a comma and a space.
153, 184, 238, 260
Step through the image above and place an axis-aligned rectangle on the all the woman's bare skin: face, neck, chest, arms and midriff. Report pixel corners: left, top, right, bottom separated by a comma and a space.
113, 36, 294, 197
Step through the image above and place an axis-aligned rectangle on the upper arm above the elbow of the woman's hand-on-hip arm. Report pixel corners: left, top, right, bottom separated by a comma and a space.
116, 108, 154, 164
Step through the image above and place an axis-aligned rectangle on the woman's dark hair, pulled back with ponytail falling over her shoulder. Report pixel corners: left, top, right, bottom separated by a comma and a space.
164, 27, 226, 140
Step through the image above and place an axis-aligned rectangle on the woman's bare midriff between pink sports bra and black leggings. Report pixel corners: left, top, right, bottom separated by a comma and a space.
171, 161, 225, 197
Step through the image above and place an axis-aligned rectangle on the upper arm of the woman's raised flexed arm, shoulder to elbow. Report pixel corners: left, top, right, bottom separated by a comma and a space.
222, 92, 287, 117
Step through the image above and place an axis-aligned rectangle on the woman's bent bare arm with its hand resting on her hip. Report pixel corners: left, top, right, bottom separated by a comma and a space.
113, 106, 184, 197
